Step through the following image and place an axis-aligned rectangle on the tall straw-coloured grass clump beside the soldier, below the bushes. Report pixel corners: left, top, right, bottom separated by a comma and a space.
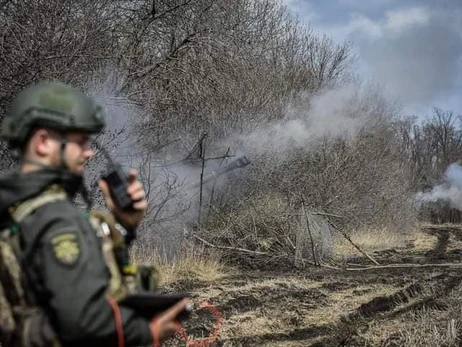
130, 245, 232, 286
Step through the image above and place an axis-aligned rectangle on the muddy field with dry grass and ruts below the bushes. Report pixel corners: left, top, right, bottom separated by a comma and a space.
148, 226, 462, 347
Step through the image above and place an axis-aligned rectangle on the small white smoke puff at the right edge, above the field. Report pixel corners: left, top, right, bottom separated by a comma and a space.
417, 163, 462, 210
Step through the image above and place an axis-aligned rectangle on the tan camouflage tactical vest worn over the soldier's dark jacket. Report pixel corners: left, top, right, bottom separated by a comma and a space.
0, 185, 157, 347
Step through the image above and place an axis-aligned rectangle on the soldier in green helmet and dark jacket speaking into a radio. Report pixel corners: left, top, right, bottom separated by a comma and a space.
0, 82, 188, 346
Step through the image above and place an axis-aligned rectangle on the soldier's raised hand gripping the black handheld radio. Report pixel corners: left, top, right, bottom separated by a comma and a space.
98, 170, 148, 229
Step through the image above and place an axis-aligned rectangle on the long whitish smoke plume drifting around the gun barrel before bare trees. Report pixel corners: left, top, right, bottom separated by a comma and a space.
85, 79, 388, 256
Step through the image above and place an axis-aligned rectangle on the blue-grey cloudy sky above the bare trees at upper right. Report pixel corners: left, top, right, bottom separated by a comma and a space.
282, 0, 462, 117
